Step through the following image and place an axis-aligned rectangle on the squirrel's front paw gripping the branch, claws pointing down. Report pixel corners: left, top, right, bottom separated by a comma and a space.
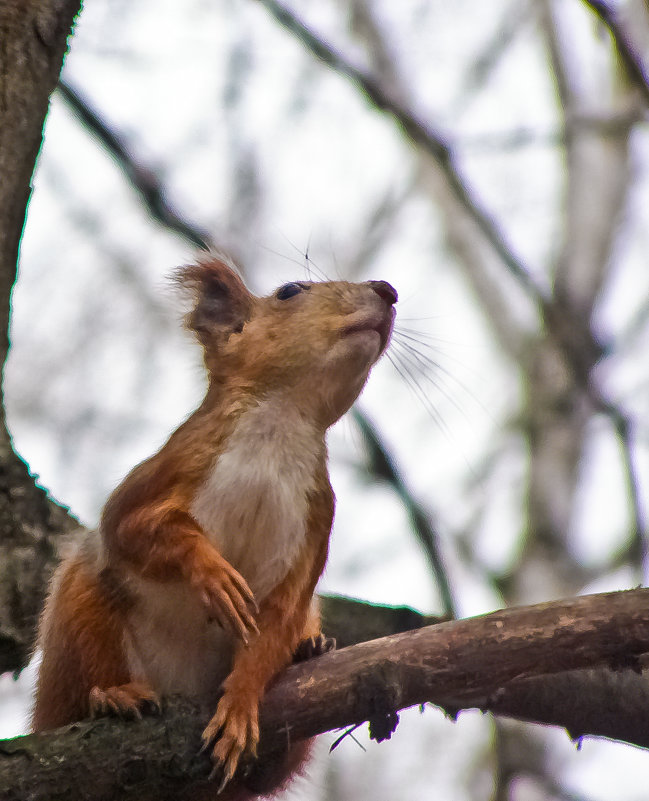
202, 692, 259, 793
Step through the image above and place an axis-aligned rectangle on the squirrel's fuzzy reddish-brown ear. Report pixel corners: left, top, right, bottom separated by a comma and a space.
175, 255, 254, 347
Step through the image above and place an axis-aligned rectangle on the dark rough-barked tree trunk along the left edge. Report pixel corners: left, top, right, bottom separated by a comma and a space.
0, 0, 85, 673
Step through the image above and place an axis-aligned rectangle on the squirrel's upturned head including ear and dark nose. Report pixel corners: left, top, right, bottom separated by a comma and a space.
177, 255, 397, 428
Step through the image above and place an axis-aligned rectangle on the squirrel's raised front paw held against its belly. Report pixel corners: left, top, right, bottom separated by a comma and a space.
191, 554, 259, 644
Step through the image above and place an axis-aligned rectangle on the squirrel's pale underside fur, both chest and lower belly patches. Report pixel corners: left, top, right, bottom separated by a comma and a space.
125, 401, 324, 702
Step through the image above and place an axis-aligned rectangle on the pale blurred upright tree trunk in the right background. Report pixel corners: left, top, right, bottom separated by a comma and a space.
506, 0, 639, 589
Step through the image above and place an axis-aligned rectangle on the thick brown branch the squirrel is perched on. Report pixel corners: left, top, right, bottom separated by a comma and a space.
0, 589, 649, 801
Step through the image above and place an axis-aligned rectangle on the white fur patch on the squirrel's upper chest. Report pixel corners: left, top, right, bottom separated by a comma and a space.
190, 400, 323, 601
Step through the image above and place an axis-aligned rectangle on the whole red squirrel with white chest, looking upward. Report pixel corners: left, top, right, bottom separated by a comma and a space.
33, 255, 397, 786
